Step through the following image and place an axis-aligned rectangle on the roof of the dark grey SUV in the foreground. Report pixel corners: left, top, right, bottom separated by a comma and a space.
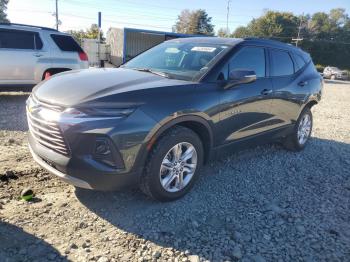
168, 37, 308, 55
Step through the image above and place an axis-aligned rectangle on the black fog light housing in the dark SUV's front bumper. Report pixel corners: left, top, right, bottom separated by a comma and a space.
93, 137, 124, 168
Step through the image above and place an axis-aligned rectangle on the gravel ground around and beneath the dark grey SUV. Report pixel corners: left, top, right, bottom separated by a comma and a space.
0, 83, 350, 262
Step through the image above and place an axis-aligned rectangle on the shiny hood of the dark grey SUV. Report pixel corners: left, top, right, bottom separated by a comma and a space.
33, 68, 190, 107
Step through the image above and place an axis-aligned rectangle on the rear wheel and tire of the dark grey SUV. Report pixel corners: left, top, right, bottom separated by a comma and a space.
283, 107, 313, 152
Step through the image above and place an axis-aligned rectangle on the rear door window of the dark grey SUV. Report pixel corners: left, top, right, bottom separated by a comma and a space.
271, 50, 294, 76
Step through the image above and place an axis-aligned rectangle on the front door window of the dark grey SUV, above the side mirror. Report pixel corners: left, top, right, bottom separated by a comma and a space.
229, 47, 265, 77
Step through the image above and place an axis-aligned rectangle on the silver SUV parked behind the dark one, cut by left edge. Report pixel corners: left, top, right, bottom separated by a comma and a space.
0, 23, 88, 86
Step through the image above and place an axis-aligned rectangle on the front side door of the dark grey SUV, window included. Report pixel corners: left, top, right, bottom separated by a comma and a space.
219, 46, 272, 144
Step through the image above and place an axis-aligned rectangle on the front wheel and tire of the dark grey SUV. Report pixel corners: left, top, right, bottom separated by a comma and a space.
140, 126, 204, 202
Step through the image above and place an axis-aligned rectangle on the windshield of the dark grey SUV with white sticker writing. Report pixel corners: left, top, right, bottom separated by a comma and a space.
122, 42, 229, 81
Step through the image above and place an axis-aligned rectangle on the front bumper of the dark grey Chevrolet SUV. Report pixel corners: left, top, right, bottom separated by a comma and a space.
27, 101, 156, 191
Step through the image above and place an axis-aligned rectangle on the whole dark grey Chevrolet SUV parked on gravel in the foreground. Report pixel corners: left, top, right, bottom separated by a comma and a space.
27, 37, 322, 201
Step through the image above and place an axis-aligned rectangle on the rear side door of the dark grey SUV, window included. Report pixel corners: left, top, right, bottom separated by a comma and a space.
269, 49, 306, 128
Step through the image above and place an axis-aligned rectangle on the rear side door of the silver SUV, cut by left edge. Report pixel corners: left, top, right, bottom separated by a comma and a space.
0, 29, 42, 84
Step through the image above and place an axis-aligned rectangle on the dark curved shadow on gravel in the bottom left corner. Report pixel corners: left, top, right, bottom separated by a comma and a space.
0, 221, 68, 262
